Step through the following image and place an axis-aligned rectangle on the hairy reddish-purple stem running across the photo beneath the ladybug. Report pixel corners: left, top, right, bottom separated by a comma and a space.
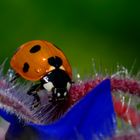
0, 62, 140, 139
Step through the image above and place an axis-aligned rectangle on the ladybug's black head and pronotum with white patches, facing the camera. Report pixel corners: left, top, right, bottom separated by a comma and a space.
42, 69, 71, 102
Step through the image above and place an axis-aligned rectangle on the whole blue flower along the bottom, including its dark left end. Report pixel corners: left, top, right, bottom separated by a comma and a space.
0, 79, 116, 140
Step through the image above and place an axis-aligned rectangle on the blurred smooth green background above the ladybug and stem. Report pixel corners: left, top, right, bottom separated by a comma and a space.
0, 0, 140, 74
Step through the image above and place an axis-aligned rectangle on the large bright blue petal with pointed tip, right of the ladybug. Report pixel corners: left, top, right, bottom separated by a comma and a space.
32, 79, 116, 140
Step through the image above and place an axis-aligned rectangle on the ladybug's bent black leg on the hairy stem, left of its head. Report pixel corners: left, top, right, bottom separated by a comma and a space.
27, 84, 41, 108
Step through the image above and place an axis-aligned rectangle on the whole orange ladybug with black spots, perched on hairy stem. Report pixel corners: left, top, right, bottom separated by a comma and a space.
10, 40, 72, 107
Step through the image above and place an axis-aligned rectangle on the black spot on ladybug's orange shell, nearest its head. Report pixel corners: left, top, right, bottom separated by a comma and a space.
48, 56, 62, 68
